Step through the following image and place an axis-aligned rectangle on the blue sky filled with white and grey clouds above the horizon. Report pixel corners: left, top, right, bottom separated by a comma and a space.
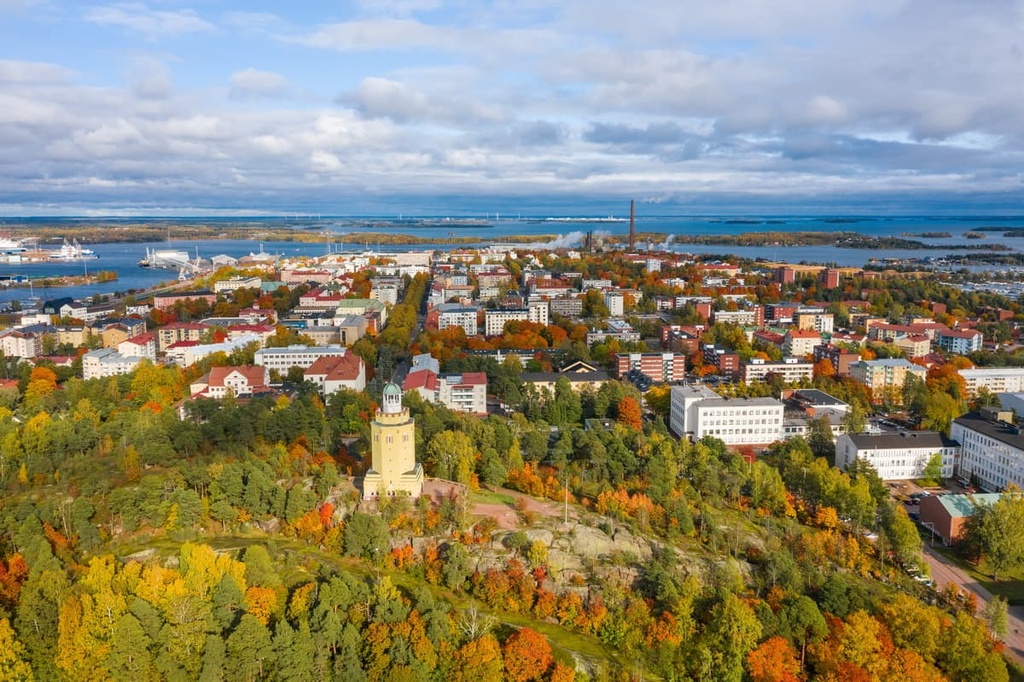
0, 0, 1024, 216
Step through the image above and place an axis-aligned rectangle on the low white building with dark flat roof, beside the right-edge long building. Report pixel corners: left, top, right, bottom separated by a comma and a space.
836, 431, 961, 480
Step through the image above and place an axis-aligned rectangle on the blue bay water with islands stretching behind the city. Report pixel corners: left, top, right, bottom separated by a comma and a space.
0, 214, 1024, 303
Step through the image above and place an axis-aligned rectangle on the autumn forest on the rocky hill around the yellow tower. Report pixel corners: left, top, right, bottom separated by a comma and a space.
0, 348, 1009, 681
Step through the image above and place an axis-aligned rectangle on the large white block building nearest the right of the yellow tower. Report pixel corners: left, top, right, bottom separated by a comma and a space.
669, 386, 783, 445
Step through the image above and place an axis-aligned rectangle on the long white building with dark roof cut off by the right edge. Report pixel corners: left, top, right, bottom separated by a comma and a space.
950, 408, 1024, 493
